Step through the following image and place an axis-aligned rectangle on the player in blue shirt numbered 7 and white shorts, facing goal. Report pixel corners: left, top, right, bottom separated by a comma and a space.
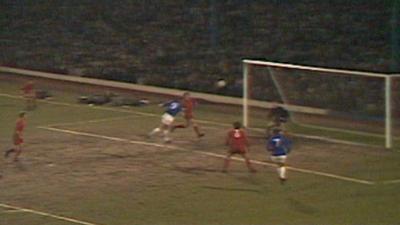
267, 128, 292, 184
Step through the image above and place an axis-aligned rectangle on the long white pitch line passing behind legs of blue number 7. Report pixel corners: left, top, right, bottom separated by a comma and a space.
38, 127, 376, 185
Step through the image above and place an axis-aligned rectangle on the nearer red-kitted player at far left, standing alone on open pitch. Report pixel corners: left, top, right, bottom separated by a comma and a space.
4, 112, 26, 162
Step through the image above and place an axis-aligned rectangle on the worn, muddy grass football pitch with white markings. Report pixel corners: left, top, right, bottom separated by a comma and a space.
0, 77, 400, 225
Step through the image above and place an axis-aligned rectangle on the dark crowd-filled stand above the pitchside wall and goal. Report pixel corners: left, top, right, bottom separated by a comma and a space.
0, 0, 400, 95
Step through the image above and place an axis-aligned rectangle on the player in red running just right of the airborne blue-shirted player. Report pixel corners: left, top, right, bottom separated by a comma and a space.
172, 92, 204, 138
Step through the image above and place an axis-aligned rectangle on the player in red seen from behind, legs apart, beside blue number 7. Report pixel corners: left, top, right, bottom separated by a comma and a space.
222, 122, 256, 173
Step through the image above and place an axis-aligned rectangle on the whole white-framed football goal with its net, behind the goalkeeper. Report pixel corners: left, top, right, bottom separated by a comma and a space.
243, 60, 400, 148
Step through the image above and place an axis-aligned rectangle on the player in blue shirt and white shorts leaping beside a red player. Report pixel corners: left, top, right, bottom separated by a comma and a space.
148, 100, 182, 143
